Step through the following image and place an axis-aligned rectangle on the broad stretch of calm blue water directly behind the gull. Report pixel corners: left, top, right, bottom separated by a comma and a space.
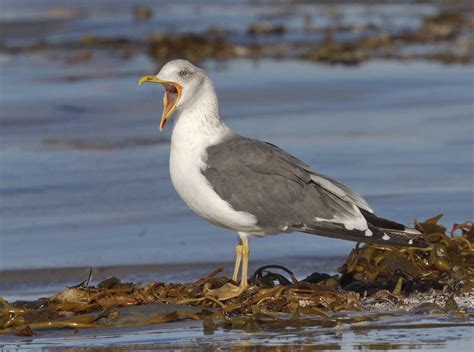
0, 54, 474, 269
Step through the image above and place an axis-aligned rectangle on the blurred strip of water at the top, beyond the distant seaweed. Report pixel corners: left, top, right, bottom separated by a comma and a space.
0, 0, 438, 44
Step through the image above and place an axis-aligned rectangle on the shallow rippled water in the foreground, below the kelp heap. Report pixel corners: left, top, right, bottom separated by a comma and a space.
0, 314, 472, 351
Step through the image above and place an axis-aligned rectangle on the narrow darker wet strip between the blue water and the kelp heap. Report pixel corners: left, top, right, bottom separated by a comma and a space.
0, 255, 345, 299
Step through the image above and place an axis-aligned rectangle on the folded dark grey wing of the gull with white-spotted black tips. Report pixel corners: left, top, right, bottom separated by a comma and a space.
202, 135, 426, 247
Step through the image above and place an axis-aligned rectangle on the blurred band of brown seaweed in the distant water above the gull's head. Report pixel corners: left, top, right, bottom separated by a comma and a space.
0, 3, 474, 65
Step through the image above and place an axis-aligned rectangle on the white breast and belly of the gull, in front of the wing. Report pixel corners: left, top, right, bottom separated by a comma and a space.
170, 108, 258, 233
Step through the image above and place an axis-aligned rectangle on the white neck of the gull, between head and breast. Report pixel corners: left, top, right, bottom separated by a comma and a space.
171, 81, 232, 151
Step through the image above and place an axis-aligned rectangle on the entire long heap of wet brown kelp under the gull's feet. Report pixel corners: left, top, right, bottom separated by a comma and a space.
0, 215, 474, 336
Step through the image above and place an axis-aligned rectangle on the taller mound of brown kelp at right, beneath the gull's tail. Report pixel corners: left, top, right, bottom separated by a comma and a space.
339, 214, 474, 294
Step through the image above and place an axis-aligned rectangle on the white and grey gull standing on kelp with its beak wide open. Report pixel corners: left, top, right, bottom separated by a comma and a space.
139, 60, 426, 300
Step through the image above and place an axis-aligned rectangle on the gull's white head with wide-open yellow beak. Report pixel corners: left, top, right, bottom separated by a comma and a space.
138, 60, 207, 131
